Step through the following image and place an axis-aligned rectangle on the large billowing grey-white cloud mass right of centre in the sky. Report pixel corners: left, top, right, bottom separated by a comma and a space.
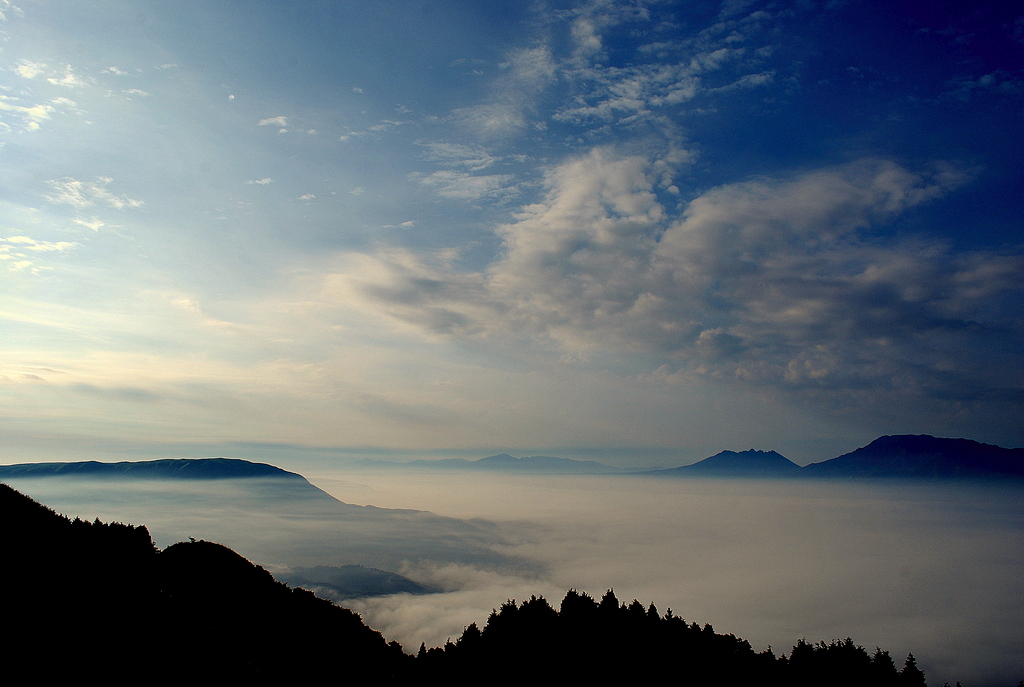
333, 148, 1024, 415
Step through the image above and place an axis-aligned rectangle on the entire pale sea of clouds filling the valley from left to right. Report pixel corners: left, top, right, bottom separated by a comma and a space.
11, 468, 1024, 687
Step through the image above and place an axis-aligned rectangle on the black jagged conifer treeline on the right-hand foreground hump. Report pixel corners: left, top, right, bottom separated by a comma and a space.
417, 590, 926, 687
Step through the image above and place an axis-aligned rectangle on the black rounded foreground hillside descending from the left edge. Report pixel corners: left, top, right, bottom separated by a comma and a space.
0, 484, 410, 685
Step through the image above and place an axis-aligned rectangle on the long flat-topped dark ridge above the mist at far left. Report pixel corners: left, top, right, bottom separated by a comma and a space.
0, 458, 308, 483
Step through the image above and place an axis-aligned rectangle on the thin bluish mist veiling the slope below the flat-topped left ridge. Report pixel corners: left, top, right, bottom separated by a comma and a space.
5, 477, 538, 575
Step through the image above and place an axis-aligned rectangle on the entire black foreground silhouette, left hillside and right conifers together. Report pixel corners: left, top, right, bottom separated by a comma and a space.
0, 483, 1007, 687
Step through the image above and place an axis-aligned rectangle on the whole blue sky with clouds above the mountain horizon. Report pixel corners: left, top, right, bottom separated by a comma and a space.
0, 0, 1024, 467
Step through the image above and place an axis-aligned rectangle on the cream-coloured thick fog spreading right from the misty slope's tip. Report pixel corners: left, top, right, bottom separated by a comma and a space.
309, 471, 1024, 687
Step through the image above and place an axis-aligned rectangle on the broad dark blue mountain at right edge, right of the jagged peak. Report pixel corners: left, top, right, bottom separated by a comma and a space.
801, 434, 1024, 479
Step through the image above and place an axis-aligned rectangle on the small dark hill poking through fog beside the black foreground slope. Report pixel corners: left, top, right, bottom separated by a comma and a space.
273, 565, 440, 601
